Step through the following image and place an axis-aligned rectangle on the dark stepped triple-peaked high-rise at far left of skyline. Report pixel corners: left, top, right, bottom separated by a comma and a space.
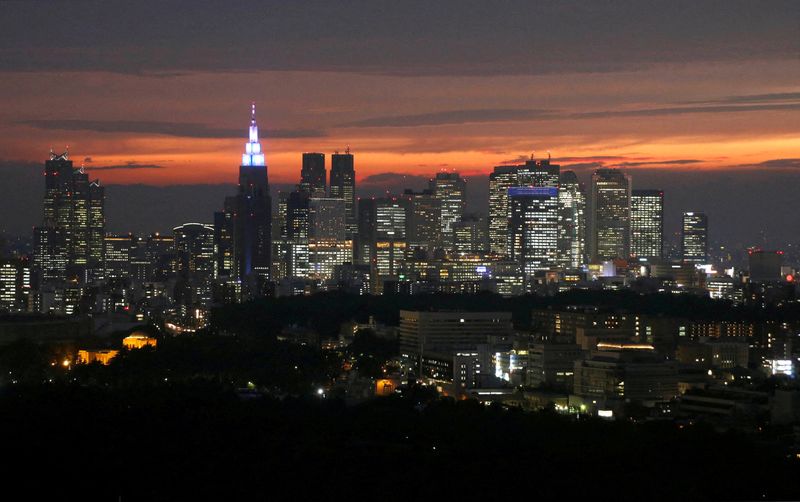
34, 152, 105, 282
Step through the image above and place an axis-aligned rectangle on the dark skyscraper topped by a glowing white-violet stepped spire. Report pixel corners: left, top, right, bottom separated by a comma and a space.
230, 103, 272, 295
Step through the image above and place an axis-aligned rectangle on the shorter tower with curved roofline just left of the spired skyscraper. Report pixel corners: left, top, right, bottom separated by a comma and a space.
172, 223, 217, 308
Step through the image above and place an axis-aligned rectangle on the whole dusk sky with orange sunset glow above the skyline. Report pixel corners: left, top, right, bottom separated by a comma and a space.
0, 0, 800, 245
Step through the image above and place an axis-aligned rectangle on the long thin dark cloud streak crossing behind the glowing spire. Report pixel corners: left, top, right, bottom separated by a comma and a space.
18, 119, 326, 139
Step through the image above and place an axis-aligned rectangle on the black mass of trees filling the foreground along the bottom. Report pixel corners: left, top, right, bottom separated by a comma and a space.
0, 382, 800, 500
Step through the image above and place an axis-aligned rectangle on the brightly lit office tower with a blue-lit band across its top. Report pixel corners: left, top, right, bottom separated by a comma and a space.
508, 187, 558, 277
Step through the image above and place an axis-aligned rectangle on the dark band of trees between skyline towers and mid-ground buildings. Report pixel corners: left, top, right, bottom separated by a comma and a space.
211, 290, 800, 338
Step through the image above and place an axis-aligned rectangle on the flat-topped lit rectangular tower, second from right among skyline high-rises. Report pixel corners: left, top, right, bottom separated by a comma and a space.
631, 190, 664, 259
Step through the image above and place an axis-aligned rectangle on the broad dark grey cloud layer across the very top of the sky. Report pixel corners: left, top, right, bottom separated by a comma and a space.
0, 0, 800, 76
